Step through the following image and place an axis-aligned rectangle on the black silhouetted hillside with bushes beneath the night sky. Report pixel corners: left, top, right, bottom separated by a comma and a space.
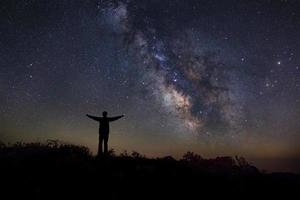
0, 140, 300, 199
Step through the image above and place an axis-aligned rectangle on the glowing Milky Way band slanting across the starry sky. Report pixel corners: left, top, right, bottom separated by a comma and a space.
104, 1, 246, 134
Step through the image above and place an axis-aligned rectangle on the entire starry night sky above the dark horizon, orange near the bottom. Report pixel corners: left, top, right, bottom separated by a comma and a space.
0, 0, 300, 172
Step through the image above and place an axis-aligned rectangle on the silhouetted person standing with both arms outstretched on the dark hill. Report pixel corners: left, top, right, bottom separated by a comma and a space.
86, 111, 124, 156
